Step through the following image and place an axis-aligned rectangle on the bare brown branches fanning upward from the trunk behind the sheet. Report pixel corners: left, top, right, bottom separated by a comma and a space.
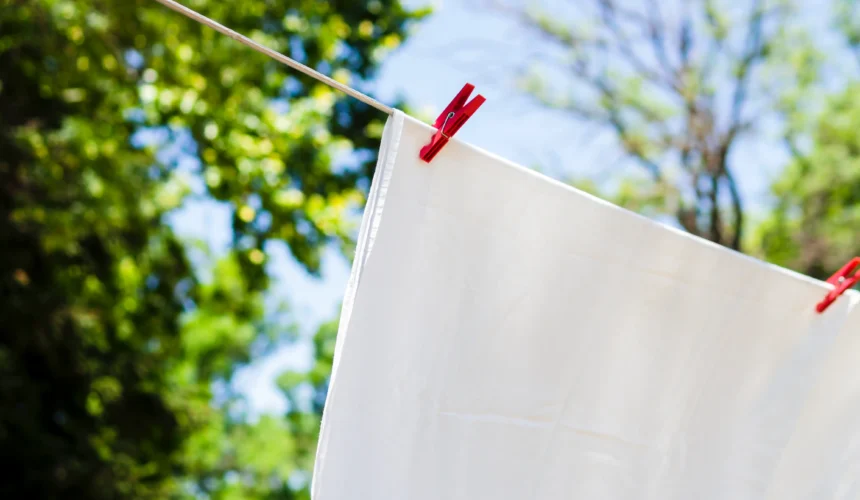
488, 0, 772, 249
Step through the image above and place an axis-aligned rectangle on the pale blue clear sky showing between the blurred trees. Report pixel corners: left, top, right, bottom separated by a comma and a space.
172, 0, 840, 412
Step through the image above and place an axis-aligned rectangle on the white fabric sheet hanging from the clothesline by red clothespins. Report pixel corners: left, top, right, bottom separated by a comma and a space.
313, 113, 860, 500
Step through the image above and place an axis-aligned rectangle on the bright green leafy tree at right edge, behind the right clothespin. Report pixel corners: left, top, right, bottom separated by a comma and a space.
756, 0, 860, 279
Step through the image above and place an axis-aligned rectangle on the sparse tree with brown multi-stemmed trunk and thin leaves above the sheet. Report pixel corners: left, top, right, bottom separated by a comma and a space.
496, 0, 794, 249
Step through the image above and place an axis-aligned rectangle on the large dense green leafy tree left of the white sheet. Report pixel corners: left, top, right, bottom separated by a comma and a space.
0, 0, 420, 499
